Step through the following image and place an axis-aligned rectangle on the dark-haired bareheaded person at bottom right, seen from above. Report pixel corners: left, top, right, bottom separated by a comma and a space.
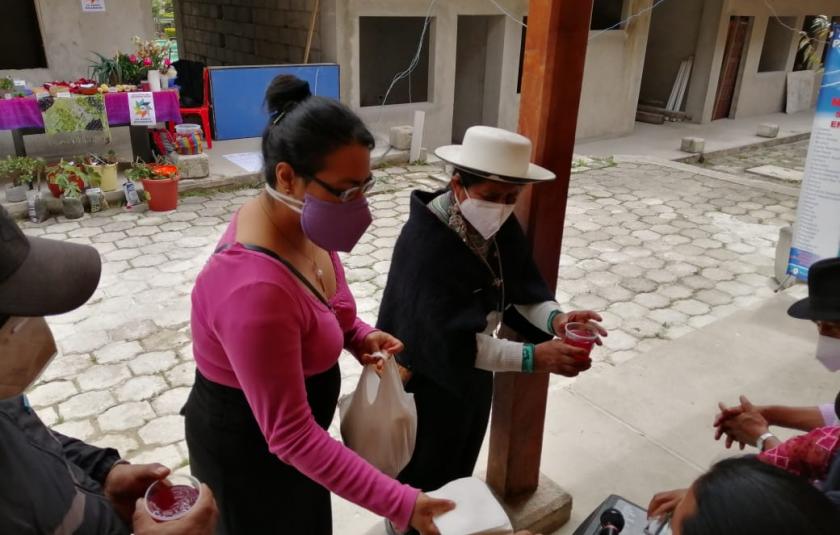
648, 457, 840, 535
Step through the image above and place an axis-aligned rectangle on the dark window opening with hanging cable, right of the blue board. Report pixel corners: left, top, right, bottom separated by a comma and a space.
359, 17, 433, 106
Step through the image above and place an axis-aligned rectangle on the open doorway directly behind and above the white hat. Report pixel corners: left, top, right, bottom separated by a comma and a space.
452, 15, 505, 144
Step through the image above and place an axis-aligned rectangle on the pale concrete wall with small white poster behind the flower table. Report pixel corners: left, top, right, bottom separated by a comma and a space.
0, 0, 154, 84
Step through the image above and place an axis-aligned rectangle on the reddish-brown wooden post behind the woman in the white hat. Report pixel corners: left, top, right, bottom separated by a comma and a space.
487, 0, 593, 501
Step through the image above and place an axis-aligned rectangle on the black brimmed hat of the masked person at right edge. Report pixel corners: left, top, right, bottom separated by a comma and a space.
788, 258, 840, 321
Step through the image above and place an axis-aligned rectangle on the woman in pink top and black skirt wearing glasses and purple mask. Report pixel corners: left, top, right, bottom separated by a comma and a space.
184, 76, 454, 535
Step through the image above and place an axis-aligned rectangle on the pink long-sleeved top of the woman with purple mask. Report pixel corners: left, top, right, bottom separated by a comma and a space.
191, 217, 419, 529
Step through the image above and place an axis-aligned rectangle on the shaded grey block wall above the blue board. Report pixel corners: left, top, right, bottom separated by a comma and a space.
175, 0, 321, 65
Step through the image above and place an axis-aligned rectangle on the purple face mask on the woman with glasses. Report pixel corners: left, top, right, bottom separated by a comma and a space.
300, 193, 373, 253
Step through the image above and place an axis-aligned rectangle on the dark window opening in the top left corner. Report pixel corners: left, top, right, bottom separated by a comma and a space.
0, 0, 47, 69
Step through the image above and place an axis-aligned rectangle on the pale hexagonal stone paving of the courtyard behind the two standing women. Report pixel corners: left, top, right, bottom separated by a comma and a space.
22, 159, 796, 482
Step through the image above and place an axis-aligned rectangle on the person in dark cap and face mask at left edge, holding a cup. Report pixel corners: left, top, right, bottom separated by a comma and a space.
0, 207, 220, 535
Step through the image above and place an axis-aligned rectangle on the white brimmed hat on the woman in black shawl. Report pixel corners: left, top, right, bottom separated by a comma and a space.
435, 126, 557, 184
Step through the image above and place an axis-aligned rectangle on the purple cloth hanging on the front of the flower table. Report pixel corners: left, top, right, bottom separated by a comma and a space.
0, 90, 181, 130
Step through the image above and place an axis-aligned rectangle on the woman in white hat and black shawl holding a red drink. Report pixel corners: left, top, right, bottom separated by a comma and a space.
377, 126, 606, 498
